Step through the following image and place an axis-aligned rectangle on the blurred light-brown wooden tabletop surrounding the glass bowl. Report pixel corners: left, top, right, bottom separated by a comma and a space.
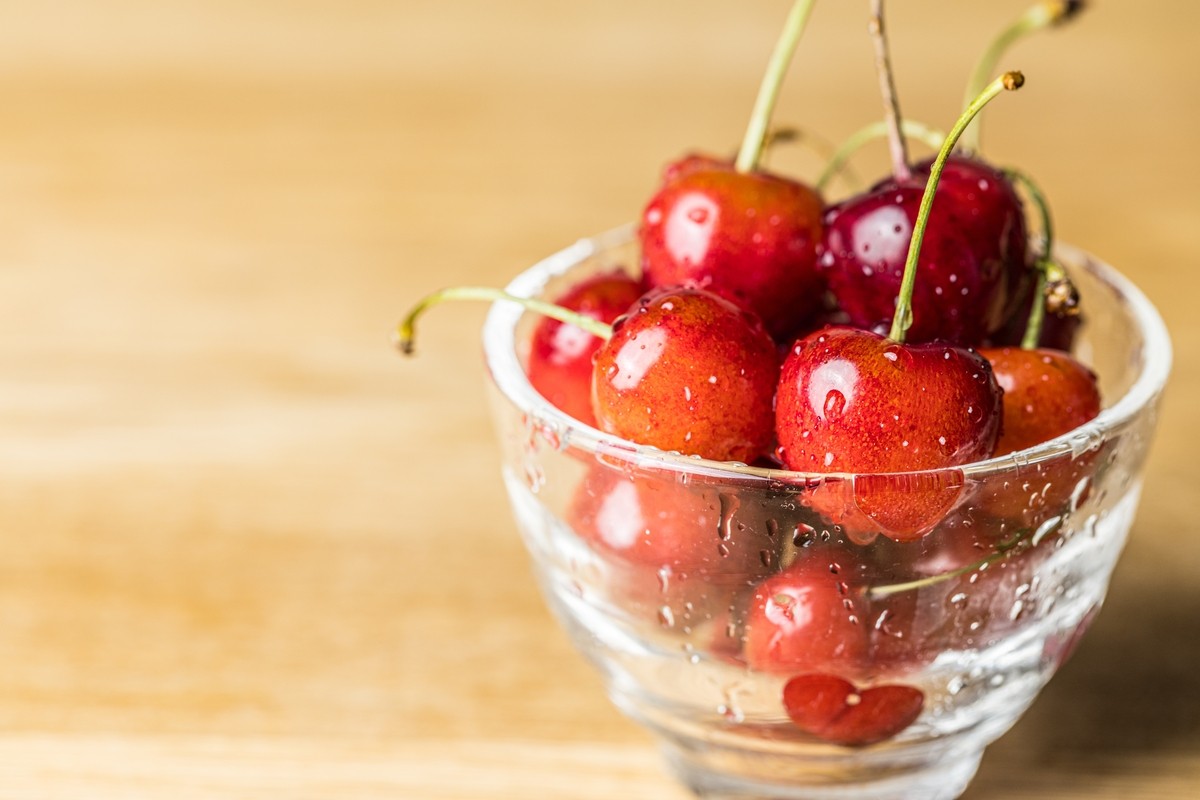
0, 0, 1200, 800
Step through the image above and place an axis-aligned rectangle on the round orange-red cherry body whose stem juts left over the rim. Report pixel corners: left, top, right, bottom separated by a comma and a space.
593, 289, 779, 462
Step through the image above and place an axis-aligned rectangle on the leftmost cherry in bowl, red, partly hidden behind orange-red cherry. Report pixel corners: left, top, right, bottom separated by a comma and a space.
528, 270, 643, 426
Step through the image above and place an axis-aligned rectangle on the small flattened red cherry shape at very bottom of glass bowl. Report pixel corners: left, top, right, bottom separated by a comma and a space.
784, 674, 925, 747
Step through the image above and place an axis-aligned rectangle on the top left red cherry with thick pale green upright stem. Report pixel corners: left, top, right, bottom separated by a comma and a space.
640, 0, 823, 336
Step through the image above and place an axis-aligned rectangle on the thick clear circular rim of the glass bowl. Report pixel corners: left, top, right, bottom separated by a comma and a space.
482, 223, 1172, 485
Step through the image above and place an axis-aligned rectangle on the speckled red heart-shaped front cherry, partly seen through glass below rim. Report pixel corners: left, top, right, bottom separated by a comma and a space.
775, 327, 1001, 541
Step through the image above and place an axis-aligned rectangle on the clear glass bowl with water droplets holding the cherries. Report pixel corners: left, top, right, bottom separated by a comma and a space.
484, 228, 1171, 800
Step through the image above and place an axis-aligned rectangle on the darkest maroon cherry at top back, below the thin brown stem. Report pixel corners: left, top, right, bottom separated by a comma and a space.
821, 160, 1025, 345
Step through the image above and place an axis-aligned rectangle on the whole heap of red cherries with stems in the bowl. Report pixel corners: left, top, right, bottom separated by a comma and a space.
401, 0, 1100, 746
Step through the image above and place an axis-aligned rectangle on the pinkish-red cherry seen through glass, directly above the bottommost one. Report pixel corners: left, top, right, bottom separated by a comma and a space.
743, 548, 870, 674
